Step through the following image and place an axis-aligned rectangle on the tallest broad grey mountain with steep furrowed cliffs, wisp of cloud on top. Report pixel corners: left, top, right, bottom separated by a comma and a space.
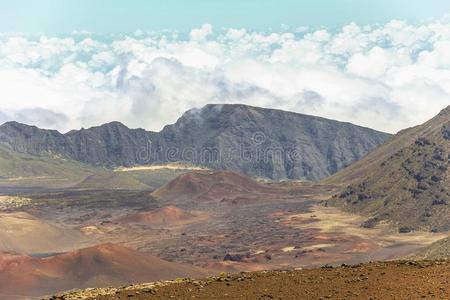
159, 105, 390, 180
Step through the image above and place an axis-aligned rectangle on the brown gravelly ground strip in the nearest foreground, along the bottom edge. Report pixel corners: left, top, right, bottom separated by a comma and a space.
50, 260, 450, 300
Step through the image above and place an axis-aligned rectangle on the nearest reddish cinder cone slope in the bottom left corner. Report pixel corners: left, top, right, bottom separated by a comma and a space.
0, 244, 207, 299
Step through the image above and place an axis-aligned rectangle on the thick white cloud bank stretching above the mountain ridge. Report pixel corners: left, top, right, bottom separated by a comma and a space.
0, 21, 450, 132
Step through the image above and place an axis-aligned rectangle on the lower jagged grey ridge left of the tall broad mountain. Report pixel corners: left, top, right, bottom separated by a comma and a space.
0, 122, 154, 167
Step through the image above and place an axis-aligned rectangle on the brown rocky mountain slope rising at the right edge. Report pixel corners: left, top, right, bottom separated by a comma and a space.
327, 107, 450, 232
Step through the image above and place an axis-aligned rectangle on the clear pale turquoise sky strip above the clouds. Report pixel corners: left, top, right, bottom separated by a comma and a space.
0, 0, 450, 34
